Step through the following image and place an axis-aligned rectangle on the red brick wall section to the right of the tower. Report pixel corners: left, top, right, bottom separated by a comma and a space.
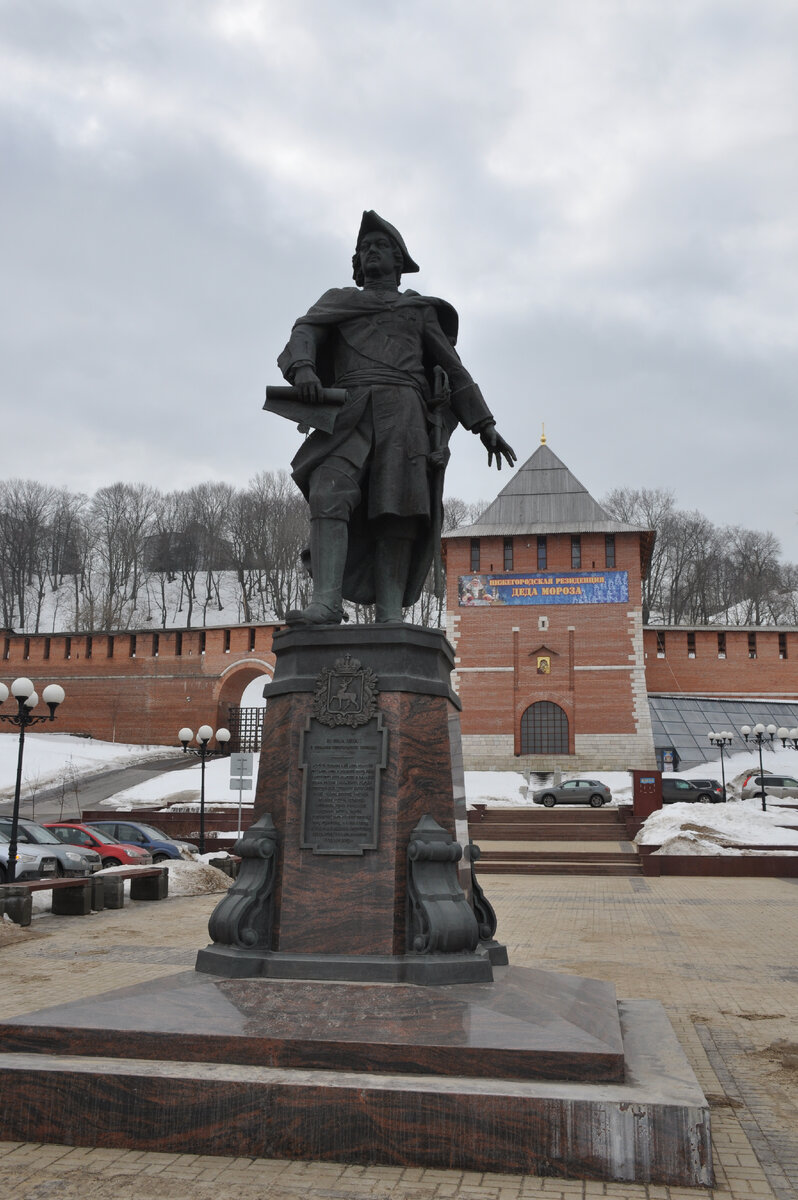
643, 625, 798, 698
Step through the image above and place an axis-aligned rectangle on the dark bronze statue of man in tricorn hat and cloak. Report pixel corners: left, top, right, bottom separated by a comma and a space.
271, 211, 516, 625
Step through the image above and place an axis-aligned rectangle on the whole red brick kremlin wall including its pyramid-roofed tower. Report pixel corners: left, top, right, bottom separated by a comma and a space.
6, 444, 798, 773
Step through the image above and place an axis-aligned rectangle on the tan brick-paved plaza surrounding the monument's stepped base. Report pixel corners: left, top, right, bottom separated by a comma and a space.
0, 872, 798, 1200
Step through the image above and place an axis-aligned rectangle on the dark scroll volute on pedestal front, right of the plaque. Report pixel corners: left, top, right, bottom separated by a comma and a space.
407, 814, 479, 954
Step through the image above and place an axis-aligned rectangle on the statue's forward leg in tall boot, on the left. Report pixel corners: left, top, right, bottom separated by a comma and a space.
286, 460, 360, 625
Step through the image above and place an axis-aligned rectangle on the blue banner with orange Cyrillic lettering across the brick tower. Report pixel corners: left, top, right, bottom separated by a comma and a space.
457, 571, 629, 608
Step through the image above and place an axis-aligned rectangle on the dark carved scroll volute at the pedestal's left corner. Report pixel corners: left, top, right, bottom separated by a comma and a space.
208, 812, 278, 950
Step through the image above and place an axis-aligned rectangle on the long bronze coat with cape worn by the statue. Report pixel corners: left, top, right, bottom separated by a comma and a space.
277, 288, 493, 606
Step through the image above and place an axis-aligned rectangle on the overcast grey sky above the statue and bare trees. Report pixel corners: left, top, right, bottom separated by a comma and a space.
0, 0, 798, 560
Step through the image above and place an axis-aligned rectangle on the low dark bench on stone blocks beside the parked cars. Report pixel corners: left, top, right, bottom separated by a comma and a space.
0, 866, 169, 925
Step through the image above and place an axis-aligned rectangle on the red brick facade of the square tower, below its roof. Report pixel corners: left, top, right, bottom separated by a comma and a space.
445, 534, 641, 752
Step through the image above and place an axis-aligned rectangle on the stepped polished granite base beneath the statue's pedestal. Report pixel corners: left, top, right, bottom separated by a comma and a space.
0, 967, 712, 1186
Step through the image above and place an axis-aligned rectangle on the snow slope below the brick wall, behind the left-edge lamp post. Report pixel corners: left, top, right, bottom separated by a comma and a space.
0, 732, 174, 799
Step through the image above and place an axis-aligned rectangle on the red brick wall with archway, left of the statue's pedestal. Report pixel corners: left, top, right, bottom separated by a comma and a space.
0, 625, 275, 745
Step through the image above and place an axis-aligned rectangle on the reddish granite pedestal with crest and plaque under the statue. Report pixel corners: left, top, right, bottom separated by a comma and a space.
197, 623, 506, 985
